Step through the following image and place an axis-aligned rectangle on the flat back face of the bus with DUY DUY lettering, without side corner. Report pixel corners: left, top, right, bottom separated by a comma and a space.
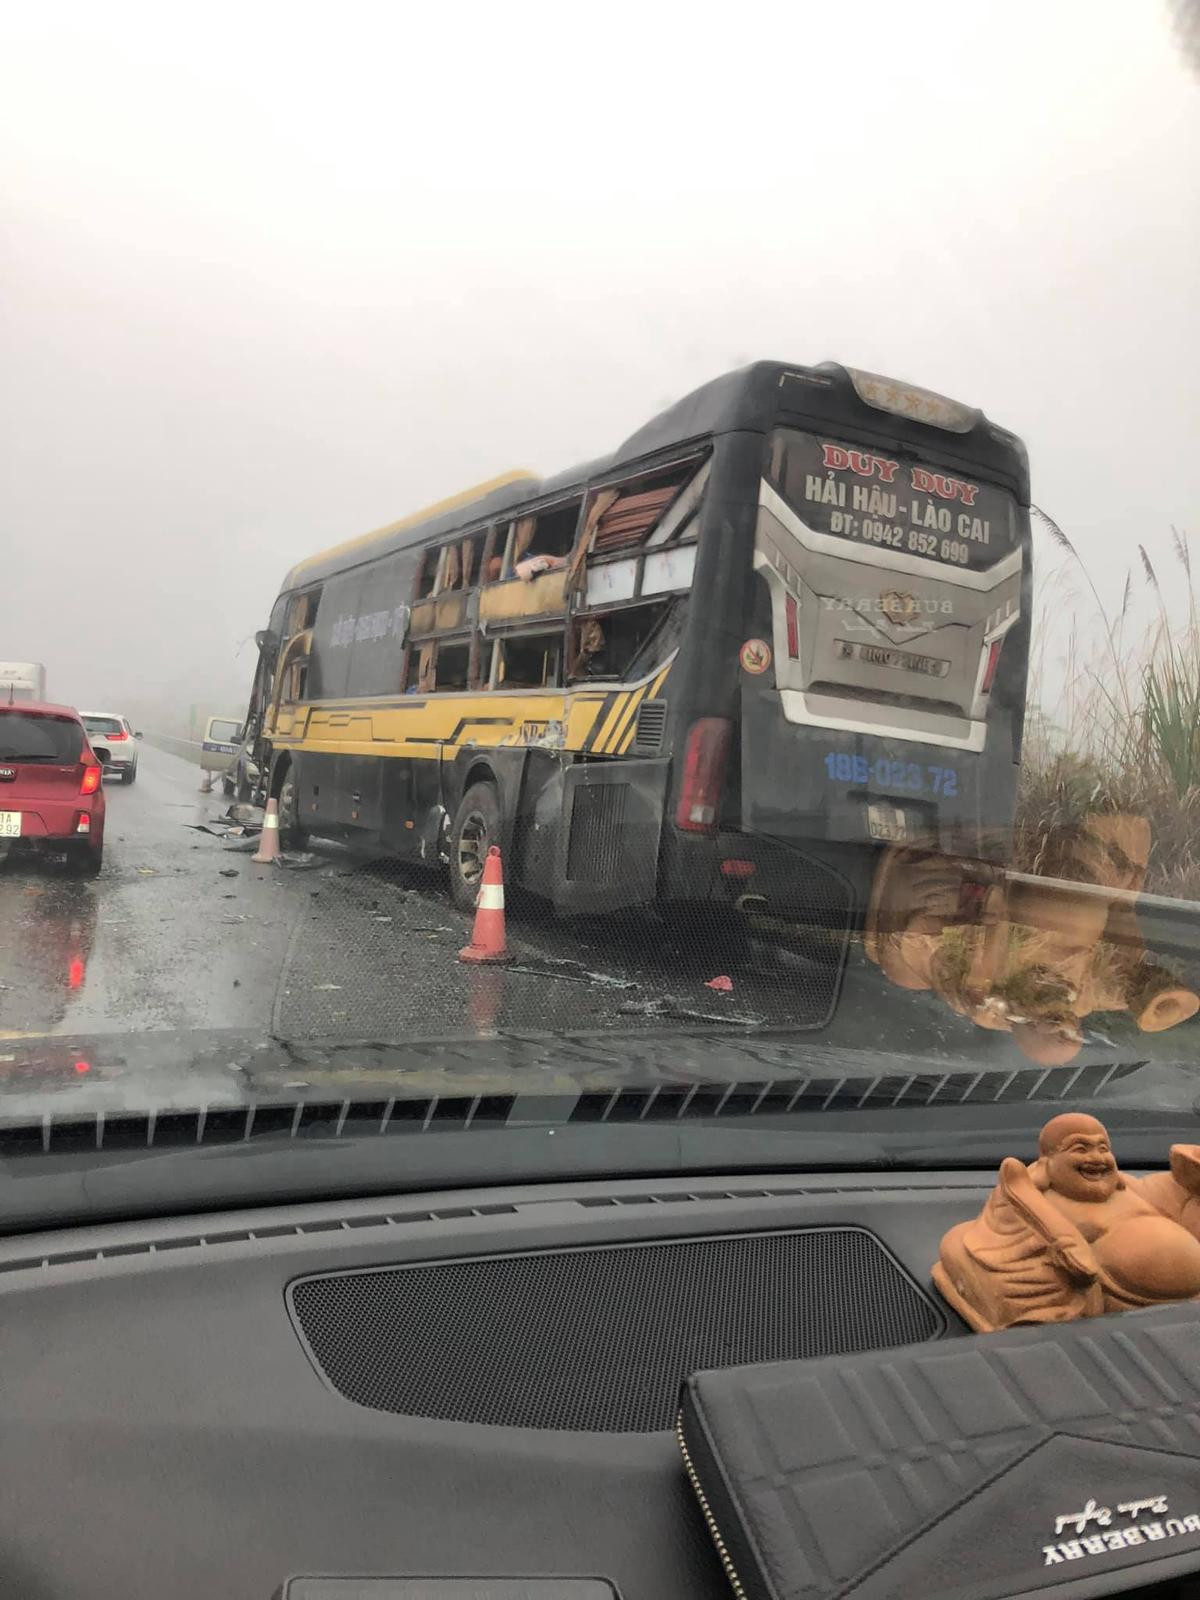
739, 366, 1029, 856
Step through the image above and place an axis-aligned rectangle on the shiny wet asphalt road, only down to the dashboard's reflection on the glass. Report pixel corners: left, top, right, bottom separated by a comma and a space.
0, 746, 857, 1042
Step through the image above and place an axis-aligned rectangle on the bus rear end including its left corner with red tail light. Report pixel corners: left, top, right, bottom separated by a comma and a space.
666, 363, 1030, 914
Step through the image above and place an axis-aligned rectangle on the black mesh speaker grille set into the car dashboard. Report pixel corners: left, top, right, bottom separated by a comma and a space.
290, 1227, 944, 1432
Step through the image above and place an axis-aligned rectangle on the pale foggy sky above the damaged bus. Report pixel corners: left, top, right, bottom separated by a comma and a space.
0, 0, 1200, 729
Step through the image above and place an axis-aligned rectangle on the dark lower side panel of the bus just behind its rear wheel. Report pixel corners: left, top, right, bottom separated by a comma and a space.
554, 758, 670, 912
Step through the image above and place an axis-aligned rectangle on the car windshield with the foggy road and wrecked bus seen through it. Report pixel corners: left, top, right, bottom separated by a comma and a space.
0, 0, 1200, 1205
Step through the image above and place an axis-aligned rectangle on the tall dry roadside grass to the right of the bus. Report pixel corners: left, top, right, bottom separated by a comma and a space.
1014, 512, 1200, 901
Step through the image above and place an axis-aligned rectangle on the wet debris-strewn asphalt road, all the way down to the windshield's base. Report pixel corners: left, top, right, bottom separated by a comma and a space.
0, 746, 1190, 1115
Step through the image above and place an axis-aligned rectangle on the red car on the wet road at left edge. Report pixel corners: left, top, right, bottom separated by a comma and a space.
0, 701, 104, 877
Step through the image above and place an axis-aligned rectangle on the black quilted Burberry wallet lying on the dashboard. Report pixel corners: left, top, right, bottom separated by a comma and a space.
678, 1302, 1200, 1600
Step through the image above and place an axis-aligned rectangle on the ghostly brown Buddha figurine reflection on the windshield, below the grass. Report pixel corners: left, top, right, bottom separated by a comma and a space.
864, 816, 1200, 1066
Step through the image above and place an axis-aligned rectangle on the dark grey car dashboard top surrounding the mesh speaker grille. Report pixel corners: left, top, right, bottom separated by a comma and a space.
0, 1173, 1190, 1600
